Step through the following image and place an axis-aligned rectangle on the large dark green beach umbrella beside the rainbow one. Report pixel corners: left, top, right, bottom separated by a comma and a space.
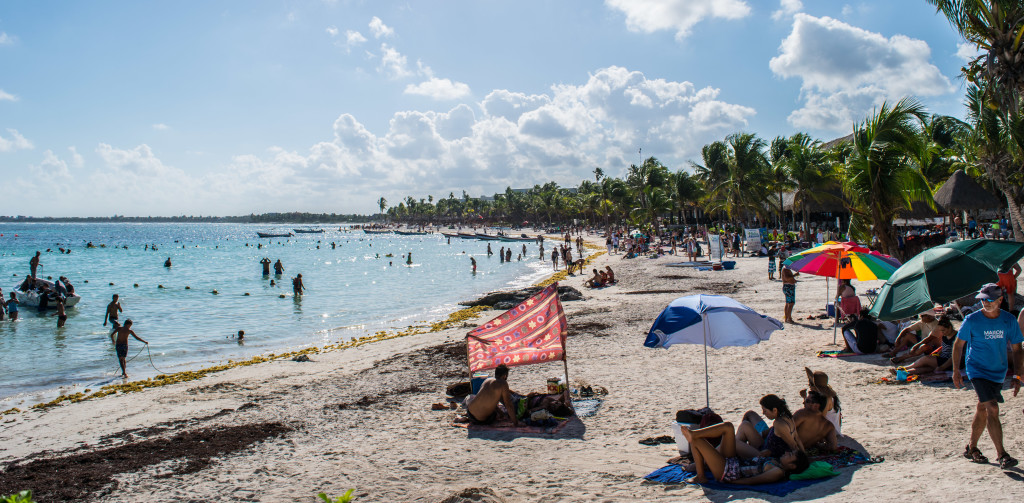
870, 240, 1024, 320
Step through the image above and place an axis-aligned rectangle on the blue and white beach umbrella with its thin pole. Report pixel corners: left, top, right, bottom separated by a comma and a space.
643, 295, 783, 407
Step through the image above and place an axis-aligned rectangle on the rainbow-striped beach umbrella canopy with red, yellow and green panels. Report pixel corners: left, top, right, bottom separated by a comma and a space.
783, 241, 901, 281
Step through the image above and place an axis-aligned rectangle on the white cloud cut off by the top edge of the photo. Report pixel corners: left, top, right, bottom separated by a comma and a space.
604, 0, 751, 39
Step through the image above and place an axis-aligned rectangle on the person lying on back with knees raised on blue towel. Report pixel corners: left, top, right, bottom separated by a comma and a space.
681, 423, 810, 486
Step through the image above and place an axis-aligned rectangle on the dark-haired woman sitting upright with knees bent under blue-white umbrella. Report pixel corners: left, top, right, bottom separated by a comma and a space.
736, 394, 804, 459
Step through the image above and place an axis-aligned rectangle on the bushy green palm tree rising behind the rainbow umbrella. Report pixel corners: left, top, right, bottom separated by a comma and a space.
843, 98, 934, 257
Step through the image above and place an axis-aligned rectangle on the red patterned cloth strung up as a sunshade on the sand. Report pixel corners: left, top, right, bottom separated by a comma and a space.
466, 283, 567, 372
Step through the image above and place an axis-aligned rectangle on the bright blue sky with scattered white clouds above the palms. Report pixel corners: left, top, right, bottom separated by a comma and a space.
0, 0, 976, 216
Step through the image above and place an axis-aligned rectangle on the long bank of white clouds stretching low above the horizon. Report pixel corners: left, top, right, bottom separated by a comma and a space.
0, 67, 755, 215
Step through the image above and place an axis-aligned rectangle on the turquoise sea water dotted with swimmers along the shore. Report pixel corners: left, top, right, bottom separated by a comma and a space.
0, 223, 551, 410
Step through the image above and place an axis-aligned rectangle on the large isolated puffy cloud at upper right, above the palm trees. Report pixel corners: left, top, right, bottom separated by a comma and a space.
769, 13, 953, 131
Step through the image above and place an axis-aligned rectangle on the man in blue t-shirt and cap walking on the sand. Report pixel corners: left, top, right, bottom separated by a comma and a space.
952, 283, 1024, 468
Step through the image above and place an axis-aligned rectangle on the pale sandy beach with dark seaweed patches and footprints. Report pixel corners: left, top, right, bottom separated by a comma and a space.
0, 238, 1024, 502
